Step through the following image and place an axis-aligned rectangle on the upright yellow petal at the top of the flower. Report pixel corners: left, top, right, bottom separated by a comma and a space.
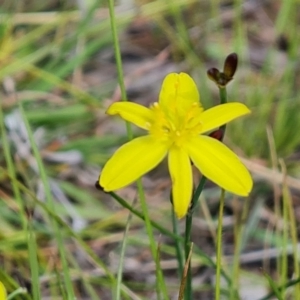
159, 73, 200, 116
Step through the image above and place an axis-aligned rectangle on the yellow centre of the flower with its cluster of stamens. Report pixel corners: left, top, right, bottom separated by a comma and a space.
149, 102, 203, 147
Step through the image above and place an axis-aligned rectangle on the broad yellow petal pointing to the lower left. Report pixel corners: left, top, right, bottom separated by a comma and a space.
99, 135, 167, 192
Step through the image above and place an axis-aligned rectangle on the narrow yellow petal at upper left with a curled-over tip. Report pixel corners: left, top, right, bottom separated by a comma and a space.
106, 101, 153, 130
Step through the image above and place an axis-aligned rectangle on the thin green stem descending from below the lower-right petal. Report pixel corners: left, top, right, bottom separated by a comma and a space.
215, 189, 225, 300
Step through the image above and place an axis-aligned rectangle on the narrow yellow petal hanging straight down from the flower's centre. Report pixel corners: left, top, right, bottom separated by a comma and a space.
168, 147, 193, 219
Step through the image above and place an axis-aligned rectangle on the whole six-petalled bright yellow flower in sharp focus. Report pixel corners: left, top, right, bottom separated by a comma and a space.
99, 73, 252, 218
